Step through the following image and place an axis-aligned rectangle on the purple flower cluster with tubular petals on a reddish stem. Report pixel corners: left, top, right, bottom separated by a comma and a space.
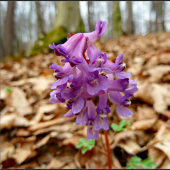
49, 20, 138, 140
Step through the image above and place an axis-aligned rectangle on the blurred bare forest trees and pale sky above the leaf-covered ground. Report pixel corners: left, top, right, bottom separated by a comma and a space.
0, 1, 170, 58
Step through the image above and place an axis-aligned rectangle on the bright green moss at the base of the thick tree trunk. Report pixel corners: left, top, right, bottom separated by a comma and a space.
30, 26, 67, 56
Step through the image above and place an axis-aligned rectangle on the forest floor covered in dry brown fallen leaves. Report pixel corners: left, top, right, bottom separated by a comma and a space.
0, 32, 170, 169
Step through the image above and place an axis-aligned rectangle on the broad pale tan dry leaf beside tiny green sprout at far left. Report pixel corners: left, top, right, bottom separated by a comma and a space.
10, 87, 32, 116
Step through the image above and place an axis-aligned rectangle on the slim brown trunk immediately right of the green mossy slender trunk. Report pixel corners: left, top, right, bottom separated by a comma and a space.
126, 1, 134, 35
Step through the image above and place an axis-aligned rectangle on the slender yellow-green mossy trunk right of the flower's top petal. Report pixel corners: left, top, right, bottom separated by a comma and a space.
113, 1, 122, 38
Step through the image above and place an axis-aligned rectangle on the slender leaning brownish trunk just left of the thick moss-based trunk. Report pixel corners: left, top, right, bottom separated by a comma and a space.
35, 1, 45, 36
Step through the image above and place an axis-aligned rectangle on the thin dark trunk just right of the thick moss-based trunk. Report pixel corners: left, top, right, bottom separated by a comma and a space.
88, 1, 94, 32
